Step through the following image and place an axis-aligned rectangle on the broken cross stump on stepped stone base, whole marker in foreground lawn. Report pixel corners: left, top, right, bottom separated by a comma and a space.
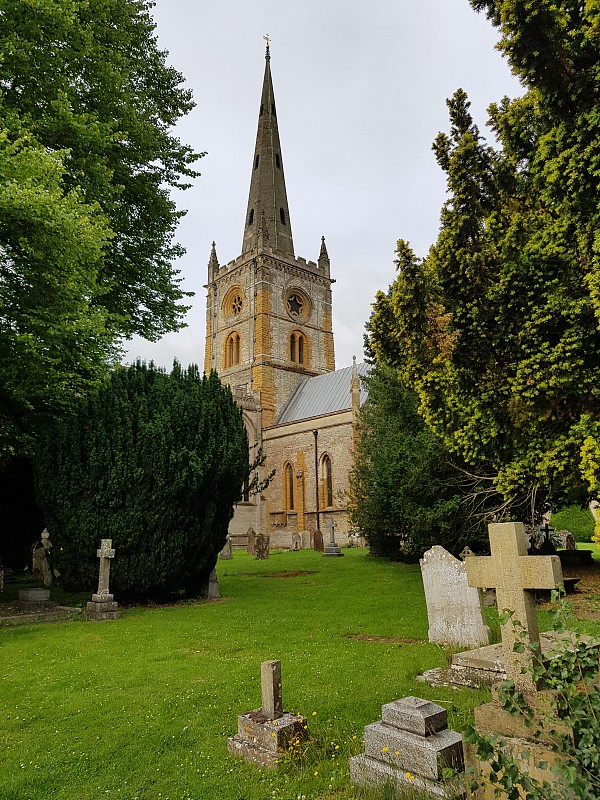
227, 660, 308, 767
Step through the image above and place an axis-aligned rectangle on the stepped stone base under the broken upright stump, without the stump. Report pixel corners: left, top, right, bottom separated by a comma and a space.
227, 708, 308, 767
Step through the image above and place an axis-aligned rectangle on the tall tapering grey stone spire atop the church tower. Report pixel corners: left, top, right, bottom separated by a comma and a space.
242, 38, 294, 256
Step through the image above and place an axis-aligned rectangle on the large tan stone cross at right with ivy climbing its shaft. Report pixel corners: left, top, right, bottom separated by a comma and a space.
465, 522, 563, 692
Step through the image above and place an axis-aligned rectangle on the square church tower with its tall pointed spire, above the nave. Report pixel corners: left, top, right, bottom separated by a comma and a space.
204, 44, 335, 427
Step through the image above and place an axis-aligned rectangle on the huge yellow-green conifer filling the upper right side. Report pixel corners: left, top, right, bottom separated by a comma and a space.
369, 0, 600, 513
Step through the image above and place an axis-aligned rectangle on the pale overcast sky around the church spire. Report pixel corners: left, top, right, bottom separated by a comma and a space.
126, 0, 521, 368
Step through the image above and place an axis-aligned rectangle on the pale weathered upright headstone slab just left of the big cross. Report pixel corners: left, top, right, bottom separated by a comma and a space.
420, 545, 490, 647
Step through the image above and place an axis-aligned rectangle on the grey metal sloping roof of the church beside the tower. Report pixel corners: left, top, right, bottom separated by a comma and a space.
277, 364, 370, 425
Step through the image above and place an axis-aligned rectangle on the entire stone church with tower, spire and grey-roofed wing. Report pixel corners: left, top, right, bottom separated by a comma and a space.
204, 43, 367, 549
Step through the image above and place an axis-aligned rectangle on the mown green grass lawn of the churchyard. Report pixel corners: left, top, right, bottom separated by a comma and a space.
0, 549, 596, 800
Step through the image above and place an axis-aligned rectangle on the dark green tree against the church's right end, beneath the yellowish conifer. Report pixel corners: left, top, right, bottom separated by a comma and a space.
350, 367, 484, 560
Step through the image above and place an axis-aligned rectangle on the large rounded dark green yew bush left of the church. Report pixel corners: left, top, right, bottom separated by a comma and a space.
35, 362, 248, 601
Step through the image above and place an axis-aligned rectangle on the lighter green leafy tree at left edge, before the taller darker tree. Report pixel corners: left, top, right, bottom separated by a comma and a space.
0, 132, 116, 463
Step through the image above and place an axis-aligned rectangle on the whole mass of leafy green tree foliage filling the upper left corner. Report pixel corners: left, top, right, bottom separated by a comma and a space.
0, 0, 199, 455
